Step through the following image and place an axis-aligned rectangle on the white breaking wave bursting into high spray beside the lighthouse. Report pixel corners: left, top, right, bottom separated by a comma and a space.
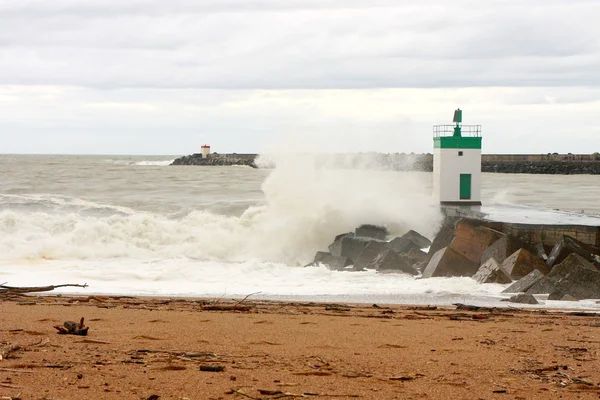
0, 155, 440, 266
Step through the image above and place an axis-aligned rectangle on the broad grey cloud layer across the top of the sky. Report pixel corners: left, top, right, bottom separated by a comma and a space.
0, 0, 600, 89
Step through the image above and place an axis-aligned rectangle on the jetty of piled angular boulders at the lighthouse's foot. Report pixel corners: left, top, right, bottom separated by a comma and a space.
308, 217, 600, 304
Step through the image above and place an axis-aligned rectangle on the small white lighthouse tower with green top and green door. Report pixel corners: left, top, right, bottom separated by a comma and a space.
433, 109, 481, 205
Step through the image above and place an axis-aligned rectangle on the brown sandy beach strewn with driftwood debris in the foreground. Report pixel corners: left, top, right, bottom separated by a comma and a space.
0, 296, 600, 400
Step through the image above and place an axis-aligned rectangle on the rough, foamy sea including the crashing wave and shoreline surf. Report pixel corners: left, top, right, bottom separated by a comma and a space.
0, 154, 600, 309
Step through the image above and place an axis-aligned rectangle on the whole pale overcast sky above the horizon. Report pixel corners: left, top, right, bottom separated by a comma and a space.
0, 0, 600, 155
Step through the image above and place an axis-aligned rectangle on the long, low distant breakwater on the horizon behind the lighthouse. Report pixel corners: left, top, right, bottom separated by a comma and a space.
171, 153, 600, 175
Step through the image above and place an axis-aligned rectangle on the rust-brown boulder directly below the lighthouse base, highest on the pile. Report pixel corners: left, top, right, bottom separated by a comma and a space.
448, 219, 500, 266
